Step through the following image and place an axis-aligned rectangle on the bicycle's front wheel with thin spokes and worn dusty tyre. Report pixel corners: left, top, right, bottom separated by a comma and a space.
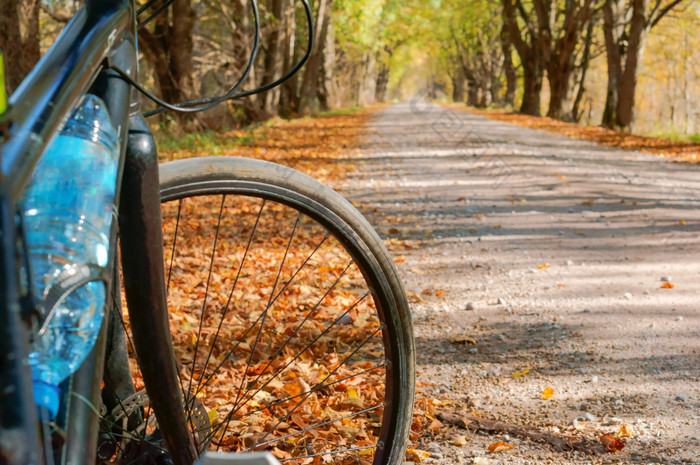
154, 157, 414, 464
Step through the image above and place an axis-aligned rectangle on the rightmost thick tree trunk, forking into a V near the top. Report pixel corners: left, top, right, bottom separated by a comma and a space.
601, 0, 684, 131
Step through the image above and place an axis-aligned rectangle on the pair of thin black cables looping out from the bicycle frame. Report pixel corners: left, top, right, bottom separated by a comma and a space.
112, 0, 313, 117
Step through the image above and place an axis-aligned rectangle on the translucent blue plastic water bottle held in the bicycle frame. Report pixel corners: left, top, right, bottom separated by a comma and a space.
22, 94, 119, 418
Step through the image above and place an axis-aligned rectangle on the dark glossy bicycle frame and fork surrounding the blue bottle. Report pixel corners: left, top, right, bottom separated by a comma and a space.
0, 0, 194, 464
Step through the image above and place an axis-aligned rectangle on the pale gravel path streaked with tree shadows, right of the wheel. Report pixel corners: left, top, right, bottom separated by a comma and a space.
340, 100, 700, 464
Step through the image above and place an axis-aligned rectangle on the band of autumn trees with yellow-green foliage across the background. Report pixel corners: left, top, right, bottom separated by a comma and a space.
0, 0, 700, 139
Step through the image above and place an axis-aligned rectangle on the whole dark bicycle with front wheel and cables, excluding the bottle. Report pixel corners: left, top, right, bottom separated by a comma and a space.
0, 0, 415, 465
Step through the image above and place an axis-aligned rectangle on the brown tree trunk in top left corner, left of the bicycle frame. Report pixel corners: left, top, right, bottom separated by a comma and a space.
0, 0, 41, 95
